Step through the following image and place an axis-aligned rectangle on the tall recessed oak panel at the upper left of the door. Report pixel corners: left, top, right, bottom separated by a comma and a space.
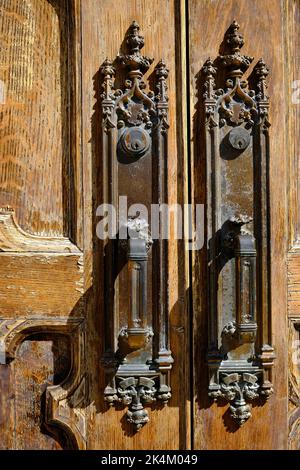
0, 0, 71, 235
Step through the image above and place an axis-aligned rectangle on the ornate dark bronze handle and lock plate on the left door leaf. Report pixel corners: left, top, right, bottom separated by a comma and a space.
101, 21, 173, 430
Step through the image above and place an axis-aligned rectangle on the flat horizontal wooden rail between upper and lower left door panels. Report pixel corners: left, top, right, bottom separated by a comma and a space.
0, 253, 84, 318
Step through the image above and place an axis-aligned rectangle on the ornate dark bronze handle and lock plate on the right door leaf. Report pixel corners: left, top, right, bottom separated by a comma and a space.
203, 21, 274, 425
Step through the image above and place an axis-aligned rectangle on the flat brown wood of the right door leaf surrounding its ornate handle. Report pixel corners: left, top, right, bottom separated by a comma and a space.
189, 0, 289, 449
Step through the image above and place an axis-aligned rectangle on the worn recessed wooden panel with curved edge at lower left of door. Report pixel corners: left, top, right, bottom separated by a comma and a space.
0, 336, 70, 450
